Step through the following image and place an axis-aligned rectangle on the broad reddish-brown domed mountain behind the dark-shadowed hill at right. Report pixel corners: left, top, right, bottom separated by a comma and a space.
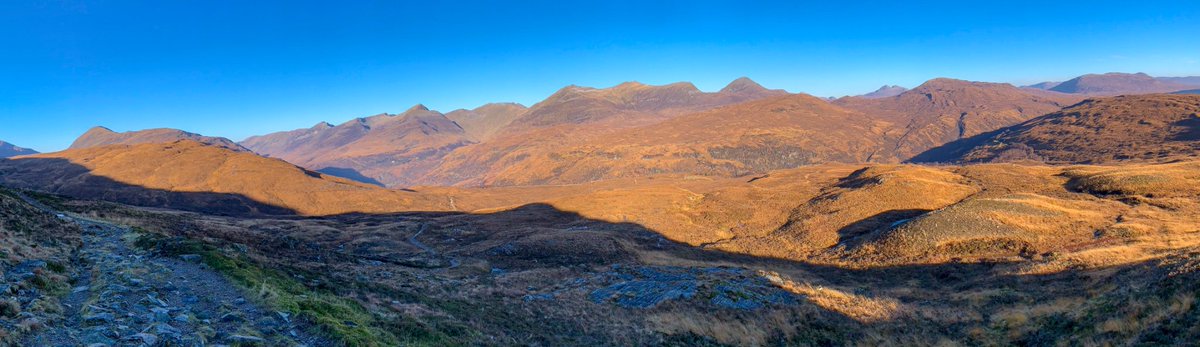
834, 78, 1078, 162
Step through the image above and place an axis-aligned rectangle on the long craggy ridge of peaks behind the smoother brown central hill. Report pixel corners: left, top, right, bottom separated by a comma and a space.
241, 78, 787, 186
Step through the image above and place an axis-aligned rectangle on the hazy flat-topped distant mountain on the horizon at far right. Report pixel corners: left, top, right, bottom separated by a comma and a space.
1049, 72, 1189, 95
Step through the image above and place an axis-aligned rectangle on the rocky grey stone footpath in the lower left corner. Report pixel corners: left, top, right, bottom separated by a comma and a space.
23, 193, 329, 346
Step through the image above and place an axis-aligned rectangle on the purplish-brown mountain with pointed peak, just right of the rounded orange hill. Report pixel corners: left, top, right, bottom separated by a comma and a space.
242, 104, 473, 186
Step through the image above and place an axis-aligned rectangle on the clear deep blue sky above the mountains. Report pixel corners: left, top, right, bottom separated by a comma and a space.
0, 0, 1200, 151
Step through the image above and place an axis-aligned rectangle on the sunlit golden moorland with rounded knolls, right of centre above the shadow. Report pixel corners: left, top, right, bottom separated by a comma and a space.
429, 161, 1200, 268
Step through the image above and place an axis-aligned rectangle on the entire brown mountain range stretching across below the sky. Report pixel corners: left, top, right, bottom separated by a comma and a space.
16, 73, 1189, 189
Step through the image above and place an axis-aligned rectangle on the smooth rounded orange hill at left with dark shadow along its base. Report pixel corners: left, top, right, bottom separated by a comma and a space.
0, 140, 442, 215
